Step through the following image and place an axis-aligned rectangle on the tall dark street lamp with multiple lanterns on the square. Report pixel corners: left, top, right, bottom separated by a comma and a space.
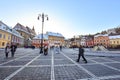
38, 13, 48, 53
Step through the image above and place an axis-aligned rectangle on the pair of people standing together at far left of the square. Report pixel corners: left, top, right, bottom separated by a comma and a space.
5, 43, 17, 58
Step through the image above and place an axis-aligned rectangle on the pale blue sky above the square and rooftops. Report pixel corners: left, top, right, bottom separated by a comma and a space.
0, 0, 120, 38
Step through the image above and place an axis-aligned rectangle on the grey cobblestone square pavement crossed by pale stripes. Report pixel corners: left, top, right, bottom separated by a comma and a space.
0, 48, 120, 80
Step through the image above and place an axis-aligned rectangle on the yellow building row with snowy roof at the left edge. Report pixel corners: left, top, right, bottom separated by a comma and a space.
0, 21, 24, 48
